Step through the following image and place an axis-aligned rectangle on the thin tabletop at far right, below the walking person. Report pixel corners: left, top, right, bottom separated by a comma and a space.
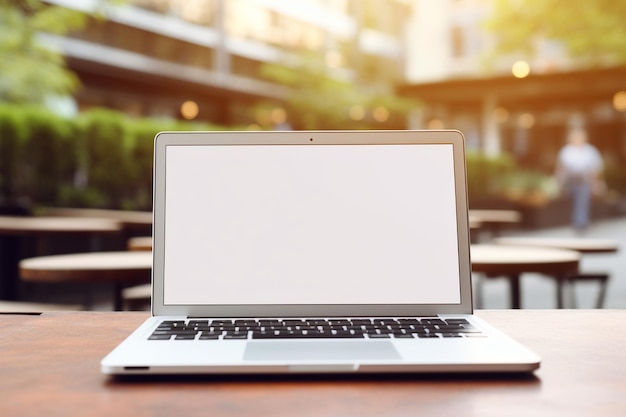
494, 236, 619, 253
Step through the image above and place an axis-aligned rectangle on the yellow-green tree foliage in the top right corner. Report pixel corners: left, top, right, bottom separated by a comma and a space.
487, 0, 626, 66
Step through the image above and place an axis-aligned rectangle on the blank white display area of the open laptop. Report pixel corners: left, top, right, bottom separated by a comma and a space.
164, 144, 460, 305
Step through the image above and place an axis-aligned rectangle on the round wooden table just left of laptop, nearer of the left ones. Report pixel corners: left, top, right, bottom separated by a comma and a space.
19, 252, 152, 310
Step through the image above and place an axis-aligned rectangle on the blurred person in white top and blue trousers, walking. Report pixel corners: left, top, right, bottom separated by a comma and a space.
555, 128, 605, 233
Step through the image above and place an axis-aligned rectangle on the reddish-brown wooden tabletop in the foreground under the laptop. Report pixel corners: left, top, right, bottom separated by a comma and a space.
0, 310, 626, 417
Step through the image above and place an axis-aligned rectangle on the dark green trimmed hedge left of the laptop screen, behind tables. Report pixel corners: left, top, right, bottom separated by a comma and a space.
0, 104, 227, 210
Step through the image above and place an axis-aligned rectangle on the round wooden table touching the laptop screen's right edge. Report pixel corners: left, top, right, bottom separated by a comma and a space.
471, 244, 580, 308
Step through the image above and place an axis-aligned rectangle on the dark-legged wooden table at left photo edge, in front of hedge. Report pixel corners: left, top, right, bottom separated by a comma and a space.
0, 216, 121, 300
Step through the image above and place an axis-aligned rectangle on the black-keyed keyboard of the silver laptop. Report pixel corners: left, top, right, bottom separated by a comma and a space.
149, 317, 484, 340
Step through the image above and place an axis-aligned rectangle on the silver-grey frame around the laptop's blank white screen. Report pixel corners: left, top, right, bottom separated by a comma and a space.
152, 130, 473, 317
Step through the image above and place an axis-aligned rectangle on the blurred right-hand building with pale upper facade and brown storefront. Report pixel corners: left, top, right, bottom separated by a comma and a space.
399, 0, 626, 171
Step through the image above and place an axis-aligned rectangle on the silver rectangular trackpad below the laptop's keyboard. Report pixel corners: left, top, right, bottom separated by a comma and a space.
244, 340, 400, 361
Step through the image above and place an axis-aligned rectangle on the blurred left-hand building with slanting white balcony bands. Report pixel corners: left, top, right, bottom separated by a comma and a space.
40, 0, 411, 125
